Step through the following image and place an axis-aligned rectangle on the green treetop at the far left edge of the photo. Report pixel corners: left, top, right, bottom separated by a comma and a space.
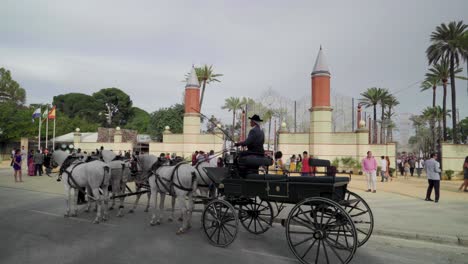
0, 68, 26, 105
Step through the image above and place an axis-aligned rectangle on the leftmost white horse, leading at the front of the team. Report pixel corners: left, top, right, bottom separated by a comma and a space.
52, 150, 110, 224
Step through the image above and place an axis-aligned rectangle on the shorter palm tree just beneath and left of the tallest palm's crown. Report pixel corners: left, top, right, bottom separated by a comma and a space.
426, 59, 462, 141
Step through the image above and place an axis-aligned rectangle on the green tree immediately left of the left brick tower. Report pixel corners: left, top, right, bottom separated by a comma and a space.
148, 104, 185, 141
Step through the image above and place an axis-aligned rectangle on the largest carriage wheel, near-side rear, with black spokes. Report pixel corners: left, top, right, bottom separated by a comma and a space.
286, 197, 357, 264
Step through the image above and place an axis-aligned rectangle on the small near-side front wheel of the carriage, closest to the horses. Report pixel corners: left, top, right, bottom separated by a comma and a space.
202, 200, 239, 247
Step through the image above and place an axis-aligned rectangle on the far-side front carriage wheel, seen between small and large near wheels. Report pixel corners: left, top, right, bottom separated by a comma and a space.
239, 198, 273, 235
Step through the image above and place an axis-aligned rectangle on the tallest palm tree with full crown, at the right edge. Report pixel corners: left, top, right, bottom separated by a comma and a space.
426, 21, 468, 143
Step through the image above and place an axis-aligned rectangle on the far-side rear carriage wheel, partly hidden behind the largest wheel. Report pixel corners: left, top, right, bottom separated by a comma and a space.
340, 191, 374, 247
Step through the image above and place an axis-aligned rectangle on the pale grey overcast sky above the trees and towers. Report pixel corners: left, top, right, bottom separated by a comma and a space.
0, 0, 468, 123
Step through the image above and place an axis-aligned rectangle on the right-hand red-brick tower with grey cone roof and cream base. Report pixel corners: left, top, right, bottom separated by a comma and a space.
309, 46, 332, 154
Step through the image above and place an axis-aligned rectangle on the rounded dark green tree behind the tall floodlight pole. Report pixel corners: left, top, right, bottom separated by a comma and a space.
93, 88, 133, 127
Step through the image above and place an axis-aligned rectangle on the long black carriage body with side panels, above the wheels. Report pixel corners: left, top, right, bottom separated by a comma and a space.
222, 174, 349, 204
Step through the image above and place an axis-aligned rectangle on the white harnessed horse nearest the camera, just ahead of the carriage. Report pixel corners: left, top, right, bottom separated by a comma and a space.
139, 156, 197, 234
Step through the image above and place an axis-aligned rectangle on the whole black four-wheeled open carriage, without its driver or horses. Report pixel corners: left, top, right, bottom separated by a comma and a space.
202, 149, 374, 263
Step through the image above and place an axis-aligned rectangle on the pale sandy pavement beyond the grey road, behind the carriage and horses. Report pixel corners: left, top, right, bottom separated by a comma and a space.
0, 162, 468, 247
